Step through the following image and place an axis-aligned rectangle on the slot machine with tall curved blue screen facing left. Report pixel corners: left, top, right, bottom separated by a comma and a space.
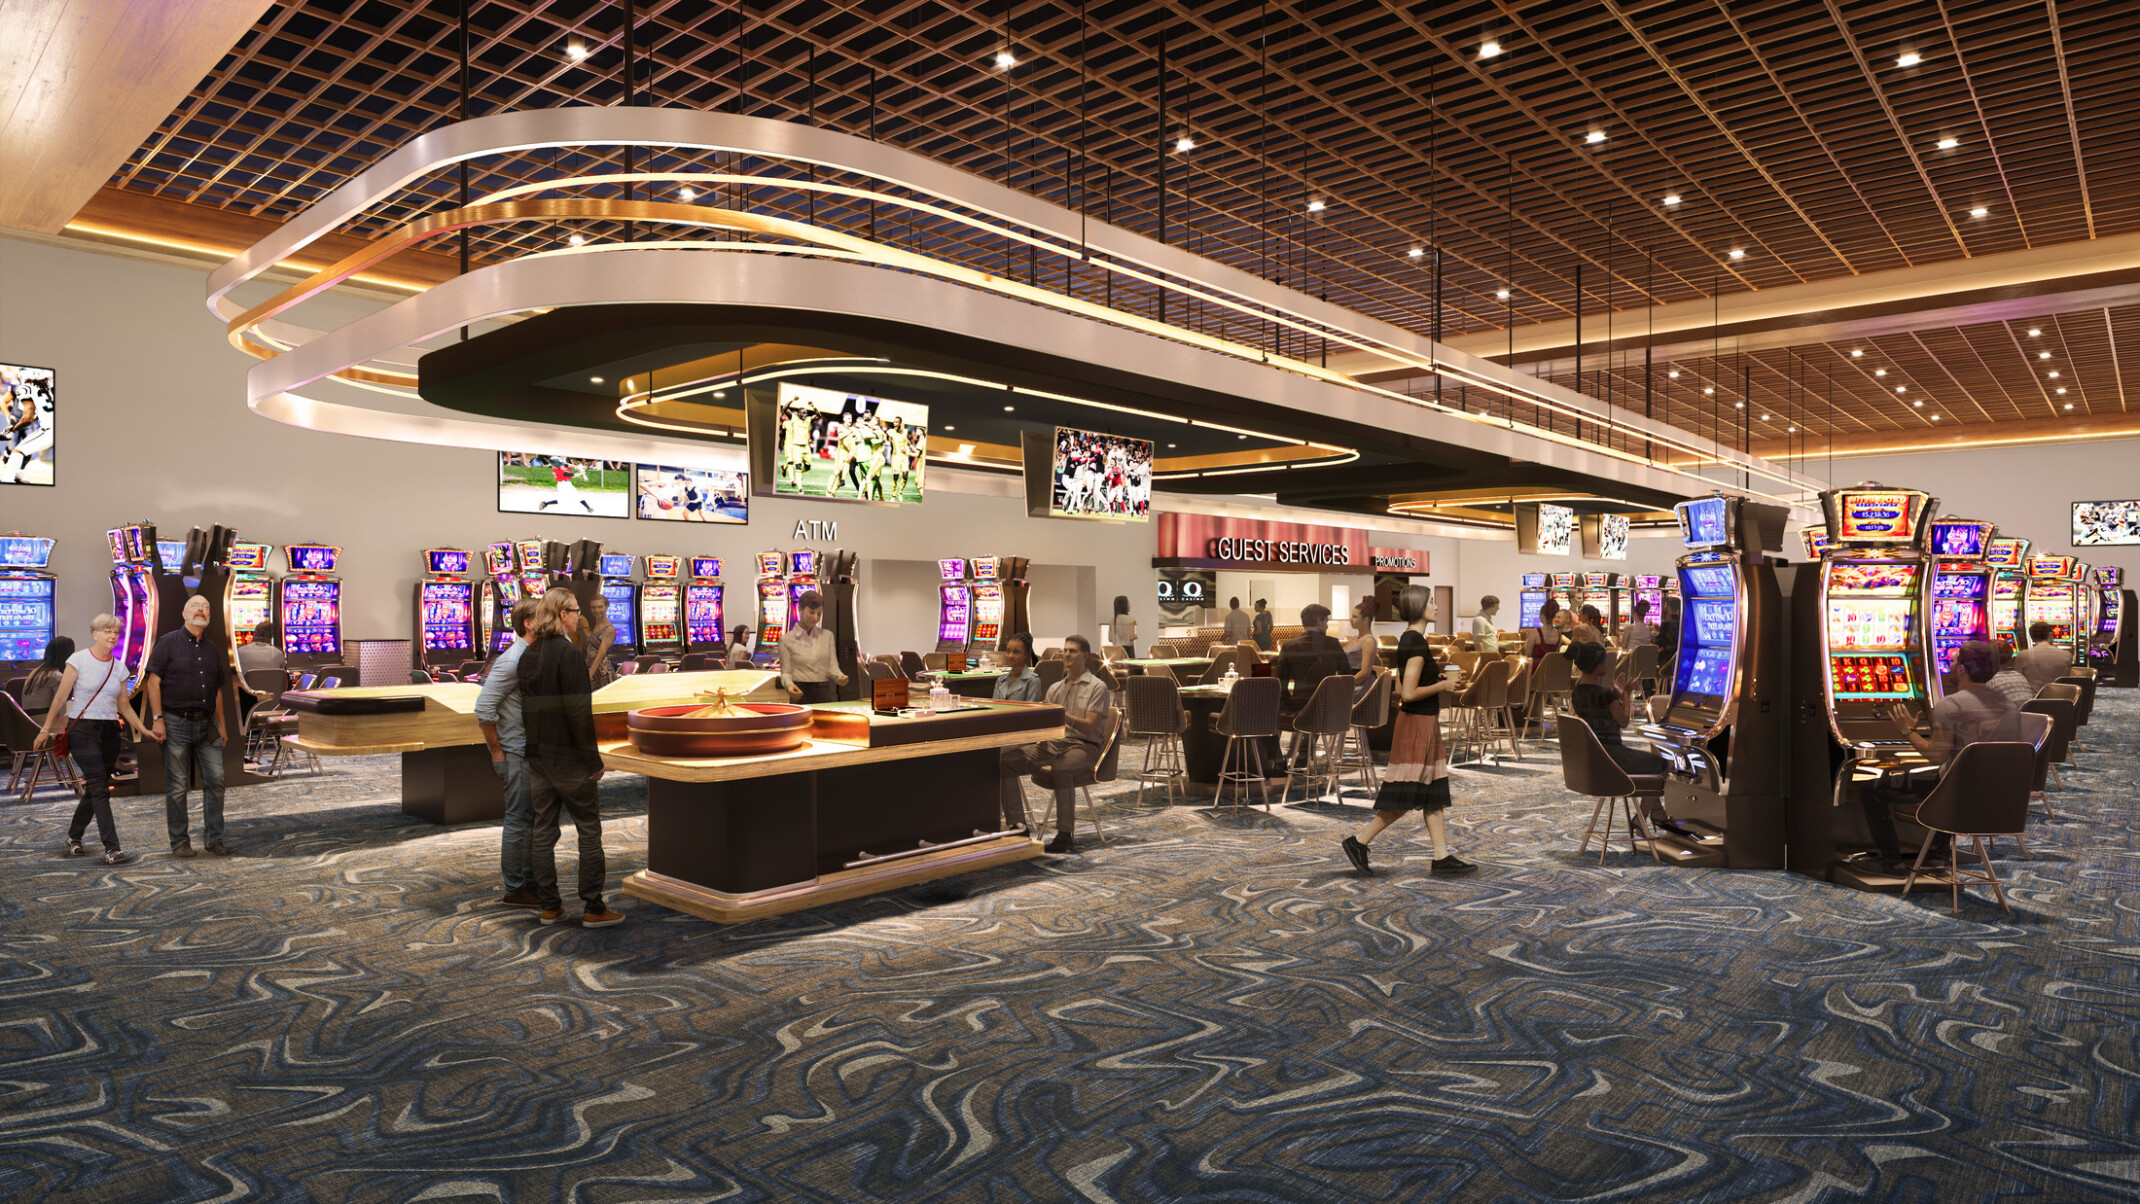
1641, 494, 1789, 868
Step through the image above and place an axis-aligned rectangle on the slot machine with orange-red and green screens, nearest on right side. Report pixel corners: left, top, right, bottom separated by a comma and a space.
1791, 483, 1965, 890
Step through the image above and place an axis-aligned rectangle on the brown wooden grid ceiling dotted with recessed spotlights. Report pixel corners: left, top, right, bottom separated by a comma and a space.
111, 0, 2140, 445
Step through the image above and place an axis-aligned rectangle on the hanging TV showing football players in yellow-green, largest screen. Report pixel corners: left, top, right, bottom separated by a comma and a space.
778, 381, 929, 503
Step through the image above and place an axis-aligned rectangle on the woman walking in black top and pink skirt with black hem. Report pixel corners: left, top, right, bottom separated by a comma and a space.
1340, 586, 1479, 877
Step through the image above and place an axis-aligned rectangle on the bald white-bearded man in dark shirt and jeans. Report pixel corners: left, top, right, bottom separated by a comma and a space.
146, 595, 231, 858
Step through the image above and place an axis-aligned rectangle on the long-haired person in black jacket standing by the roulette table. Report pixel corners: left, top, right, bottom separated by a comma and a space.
514, 588, 625, 928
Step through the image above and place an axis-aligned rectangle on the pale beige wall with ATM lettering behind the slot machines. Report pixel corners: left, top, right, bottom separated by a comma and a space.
0, 237, 1158, 650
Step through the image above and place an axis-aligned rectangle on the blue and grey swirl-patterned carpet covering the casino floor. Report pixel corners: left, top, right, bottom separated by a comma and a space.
0, 691, 2140, 1202
